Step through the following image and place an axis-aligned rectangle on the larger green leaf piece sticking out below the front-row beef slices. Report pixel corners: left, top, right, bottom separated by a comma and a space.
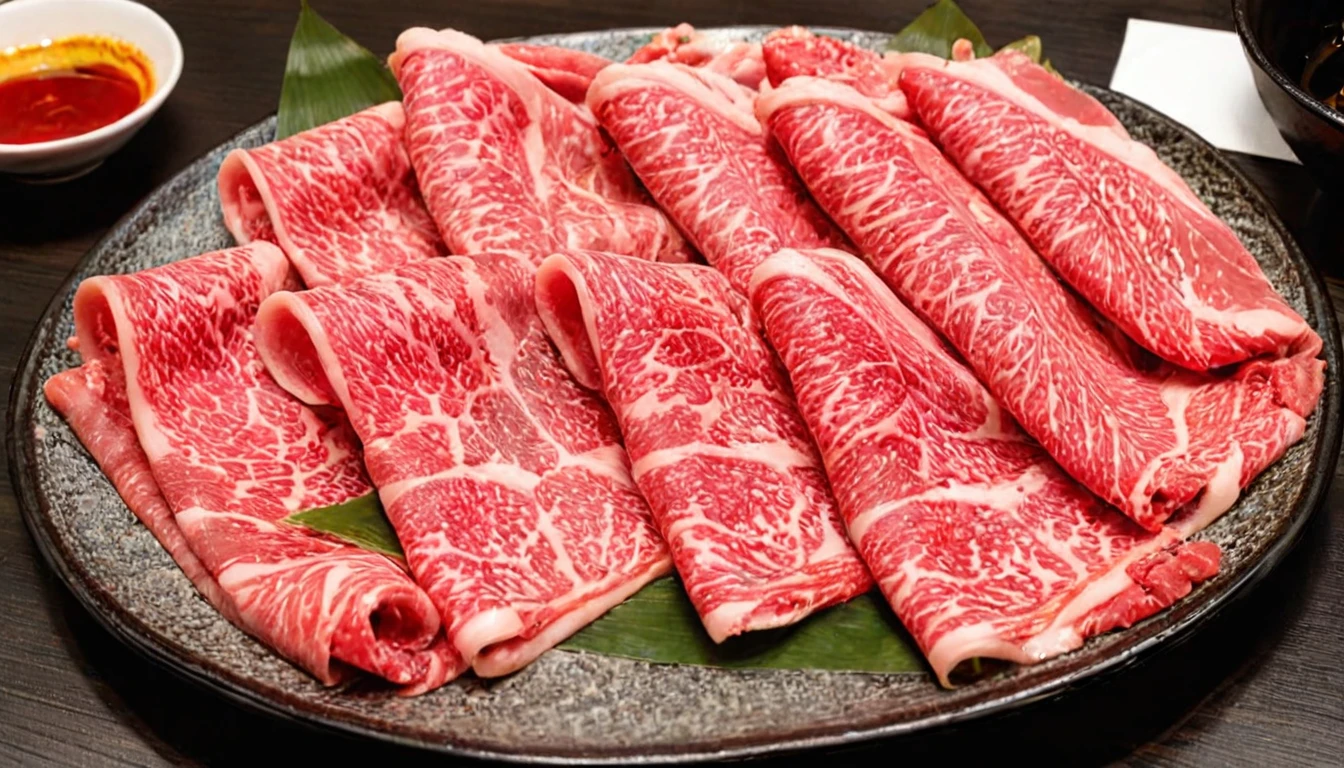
559, 577, 925, 674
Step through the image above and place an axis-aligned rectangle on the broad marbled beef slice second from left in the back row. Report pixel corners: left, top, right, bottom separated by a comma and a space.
391, 28, 692, 264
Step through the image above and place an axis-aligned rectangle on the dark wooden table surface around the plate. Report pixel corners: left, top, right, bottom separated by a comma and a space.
0, 0, 1344, 767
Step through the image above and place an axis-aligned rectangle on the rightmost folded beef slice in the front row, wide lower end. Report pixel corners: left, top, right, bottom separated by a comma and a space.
751, 250, 1219, 686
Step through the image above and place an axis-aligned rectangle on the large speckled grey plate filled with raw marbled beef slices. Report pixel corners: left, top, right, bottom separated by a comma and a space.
8, 26, 1340, 761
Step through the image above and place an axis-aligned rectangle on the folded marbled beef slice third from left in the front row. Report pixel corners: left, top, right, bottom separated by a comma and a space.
536, 252, 872, 642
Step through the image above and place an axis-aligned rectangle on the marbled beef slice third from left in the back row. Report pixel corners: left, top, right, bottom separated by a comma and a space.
587, 62, 844, 293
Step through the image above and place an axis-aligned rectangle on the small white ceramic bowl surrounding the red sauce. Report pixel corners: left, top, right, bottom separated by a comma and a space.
0, 0, 183, 182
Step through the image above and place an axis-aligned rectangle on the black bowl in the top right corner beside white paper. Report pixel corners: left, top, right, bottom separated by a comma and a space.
1232, 0, 1344, 192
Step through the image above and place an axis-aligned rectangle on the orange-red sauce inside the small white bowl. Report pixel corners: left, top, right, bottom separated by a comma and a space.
0, 36, 153, 144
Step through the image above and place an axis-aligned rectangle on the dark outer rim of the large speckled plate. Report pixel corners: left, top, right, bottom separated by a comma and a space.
5, 26, 1341, 765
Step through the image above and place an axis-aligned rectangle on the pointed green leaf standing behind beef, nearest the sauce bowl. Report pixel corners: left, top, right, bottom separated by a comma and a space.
276, 0, 402, 139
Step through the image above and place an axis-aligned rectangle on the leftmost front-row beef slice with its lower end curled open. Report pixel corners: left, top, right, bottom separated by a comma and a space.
68, 242, 461, 691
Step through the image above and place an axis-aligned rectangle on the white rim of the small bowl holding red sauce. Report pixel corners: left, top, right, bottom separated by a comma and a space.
0, 0, 184, 159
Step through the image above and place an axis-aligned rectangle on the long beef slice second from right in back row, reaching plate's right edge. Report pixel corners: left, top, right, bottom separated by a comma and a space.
758, 78, 1324, 531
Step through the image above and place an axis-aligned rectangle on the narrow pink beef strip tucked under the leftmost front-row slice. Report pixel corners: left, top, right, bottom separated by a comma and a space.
43, 360, 238, 624
